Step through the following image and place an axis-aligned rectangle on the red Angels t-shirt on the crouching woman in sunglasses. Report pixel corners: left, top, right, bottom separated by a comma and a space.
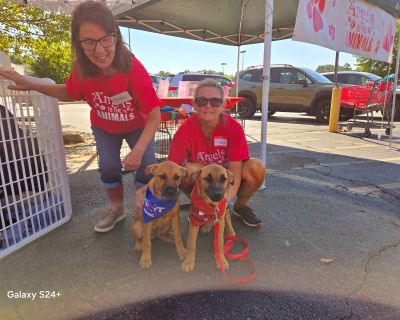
168, 113, 250, 166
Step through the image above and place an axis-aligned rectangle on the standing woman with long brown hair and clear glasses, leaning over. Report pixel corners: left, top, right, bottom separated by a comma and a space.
0, 1, 160, 232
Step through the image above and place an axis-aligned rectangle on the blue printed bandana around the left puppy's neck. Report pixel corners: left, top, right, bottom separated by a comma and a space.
142, 188, 178, 223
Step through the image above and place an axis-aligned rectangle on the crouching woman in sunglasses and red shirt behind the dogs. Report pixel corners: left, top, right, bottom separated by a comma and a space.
168, 79, 265, 227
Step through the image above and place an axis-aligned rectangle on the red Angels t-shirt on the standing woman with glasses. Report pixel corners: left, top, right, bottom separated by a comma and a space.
66, 56, 161, 133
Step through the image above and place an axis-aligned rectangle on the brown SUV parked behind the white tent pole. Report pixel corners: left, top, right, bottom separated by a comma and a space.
229, 64, 353, 122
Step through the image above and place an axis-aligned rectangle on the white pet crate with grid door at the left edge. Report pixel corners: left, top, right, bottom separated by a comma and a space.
0, 79, 72, 258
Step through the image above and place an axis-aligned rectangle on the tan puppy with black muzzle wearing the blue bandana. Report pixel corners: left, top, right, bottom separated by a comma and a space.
131, 161, 187, 269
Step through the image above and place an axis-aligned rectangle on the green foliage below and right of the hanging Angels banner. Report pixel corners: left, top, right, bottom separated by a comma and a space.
356, 22, 400, 77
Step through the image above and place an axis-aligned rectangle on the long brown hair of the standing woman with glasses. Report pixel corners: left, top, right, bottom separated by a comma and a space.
71, 1, 132, 78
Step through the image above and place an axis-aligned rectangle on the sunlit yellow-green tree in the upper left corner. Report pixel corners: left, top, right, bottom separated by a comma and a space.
0, 0, 71, 82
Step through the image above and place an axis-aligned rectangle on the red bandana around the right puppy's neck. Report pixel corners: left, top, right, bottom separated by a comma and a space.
190, 183, 226, 227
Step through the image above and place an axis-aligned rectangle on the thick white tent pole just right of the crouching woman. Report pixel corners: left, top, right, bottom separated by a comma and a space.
260, 0, 274, 189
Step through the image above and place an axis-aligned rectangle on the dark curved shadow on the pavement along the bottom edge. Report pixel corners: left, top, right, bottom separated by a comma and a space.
77, 290, 400, 320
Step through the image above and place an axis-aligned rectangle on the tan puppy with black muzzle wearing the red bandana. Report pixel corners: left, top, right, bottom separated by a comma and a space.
182, 164, 234, 272
